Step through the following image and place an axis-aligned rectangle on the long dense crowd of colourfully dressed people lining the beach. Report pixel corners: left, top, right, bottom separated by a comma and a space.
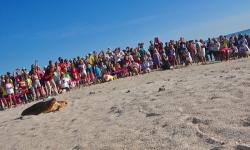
0, 35, 250, 110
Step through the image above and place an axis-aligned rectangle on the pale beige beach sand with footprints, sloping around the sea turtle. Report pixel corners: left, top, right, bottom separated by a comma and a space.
0, 58, 250, 150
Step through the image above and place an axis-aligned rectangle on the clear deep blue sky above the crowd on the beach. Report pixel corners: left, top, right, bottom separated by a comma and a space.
0, 0, 250, 73
